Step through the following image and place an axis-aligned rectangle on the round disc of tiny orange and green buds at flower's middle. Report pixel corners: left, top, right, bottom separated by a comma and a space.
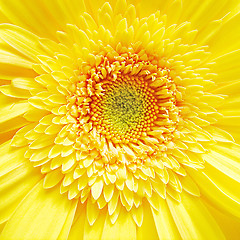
91, 75, 158, 143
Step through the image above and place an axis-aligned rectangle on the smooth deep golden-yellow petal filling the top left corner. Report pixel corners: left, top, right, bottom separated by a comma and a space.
0, 0, 78, 38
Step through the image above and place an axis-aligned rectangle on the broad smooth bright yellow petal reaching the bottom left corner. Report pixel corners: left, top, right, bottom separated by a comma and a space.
0, 181, 72, 240
